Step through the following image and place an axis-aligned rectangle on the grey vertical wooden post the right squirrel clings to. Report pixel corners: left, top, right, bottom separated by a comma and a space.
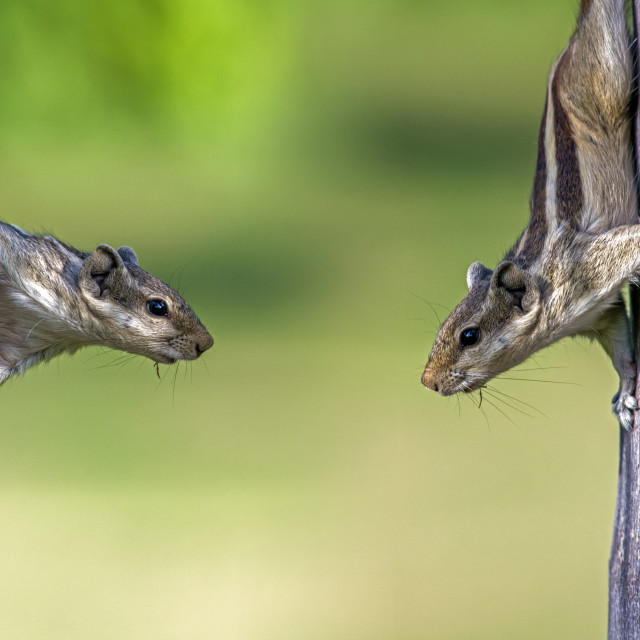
608, 0, 640, 640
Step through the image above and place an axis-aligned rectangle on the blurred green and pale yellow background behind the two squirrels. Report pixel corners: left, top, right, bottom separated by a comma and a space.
0, 0, 618, 640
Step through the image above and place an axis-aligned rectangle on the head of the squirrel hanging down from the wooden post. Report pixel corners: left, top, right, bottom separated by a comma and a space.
422, 261, 541, 396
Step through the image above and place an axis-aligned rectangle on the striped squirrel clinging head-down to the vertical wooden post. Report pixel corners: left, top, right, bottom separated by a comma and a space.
422, 0, 640, 430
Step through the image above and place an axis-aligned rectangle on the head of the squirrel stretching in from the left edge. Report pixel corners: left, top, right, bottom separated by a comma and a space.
78, 244, 213, 364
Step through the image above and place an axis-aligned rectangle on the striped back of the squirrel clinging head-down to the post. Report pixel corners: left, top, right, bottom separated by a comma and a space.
505, 0, 638, 267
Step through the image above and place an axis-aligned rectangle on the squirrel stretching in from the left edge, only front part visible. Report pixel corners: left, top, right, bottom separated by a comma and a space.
0, 222, 213, 384
